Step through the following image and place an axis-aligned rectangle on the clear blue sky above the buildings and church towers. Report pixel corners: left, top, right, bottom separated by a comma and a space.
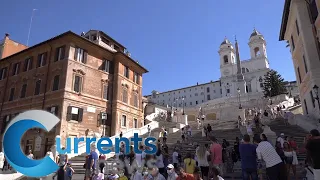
0, 0, 296, 95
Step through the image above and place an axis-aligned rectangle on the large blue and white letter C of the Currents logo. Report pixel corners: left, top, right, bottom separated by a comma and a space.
3, 110, 60, 177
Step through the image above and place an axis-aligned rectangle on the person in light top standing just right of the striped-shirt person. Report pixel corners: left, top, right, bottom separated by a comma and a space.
283, 142, 299, 180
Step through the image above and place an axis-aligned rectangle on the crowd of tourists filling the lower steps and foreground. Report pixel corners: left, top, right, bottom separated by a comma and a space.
35, 104, 320, 180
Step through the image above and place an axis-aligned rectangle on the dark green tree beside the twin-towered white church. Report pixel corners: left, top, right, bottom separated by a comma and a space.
263, 69, 287, 97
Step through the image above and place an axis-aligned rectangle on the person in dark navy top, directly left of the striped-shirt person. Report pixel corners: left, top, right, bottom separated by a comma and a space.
239, 134, 258, 180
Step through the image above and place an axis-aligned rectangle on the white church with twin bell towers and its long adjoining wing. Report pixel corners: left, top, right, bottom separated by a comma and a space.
146, 29, 269, 107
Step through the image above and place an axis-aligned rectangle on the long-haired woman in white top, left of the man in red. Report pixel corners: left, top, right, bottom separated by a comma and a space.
196, 144, 210, 180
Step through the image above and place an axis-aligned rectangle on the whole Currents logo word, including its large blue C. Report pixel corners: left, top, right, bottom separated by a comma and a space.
3, 110, 157, 177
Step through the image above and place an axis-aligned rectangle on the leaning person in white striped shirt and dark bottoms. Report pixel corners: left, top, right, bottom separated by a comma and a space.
254, 136, 287, 180
